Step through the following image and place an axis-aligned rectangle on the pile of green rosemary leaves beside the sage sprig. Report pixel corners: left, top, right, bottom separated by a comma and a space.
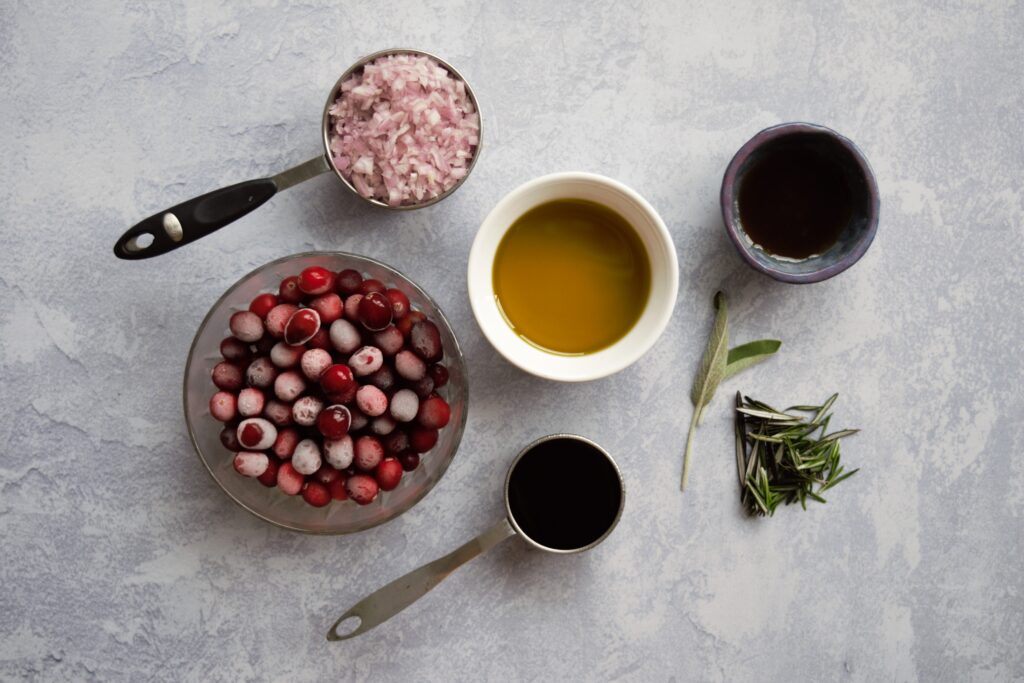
736, 391, 859, 516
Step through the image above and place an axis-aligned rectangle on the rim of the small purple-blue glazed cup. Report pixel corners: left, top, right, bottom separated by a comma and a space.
719, 121, 880, 285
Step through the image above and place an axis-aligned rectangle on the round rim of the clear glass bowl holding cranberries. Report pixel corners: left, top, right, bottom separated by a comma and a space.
181, 250, 469, 536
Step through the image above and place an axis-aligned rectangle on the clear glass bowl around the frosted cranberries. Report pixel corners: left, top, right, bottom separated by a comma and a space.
183, 252, 469, 533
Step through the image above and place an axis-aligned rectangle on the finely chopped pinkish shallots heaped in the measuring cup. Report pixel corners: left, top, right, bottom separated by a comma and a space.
330, 54, 480, 206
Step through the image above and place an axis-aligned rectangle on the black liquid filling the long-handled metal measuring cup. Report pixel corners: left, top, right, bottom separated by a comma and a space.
508, 438, 623, 550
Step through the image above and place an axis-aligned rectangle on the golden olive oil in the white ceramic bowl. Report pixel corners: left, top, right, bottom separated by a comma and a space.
494, 200, 650, 355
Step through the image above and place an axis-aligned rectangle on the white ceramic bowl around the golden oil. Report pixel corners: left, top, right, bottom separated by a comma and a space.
467, 172, 679, 382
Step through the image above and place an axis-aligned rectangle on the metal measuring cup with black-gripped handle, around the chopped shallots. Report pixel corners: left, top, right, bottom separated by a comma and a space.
114, 48, 483, 260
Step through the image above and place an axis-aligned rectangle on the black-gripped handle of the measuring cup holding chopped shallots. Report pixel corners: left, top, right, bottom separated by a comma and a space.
114, 155, 331, 260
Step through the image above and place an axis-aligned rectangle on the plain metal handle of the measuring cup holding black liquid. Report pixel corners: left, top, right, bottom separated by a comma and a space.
327, 518, 515, 640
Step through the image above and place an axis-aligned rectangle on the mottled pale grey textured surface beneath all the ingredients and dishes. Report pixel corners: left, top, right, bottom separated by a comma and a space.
0, 0, 1024, 681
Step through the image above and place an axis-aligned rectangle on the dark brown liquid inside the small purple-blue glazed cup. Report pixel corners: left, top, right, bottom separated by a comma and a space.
738, 145, 854, 258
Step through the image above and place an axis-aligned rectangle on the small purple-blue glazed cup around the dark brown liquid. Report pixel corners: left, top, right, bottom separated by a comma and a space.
721, 123, 879, 285
